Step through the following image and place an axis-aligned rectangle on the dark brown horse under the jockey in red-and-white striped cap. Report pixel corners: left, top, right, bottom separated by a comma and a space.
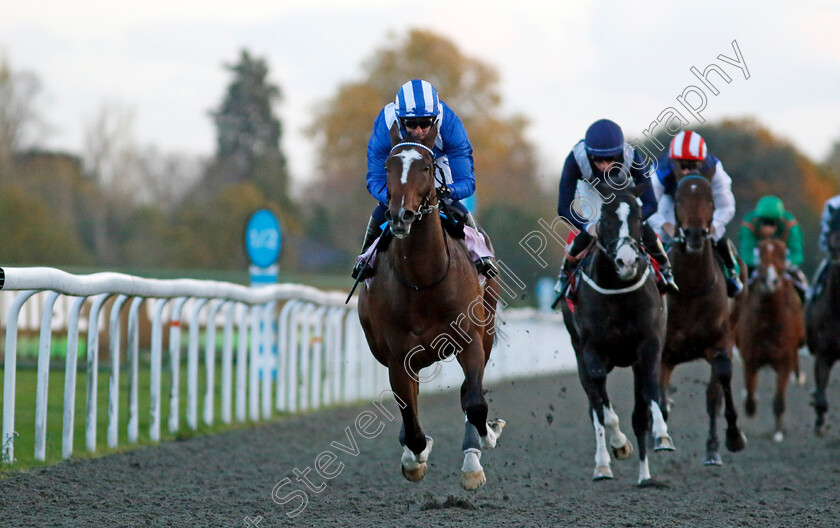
659, 176, 747, 466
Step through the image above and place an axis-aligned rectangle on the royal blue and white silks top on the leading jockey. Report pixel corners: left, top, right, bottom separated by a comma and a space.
367, 101, 475, 205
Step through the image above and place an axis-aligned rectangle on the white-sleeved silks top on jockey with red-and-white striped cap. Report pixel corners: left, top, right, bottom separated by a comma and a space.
648, 154, 735, 242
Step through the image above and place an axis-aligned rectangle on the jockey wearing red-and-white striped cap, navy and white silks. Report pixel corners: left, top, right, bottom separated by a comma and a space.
648, 130, 744, 297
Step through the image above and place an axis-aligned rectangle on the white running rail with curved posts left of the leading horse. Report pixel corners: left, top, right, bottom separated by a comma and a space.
0, 268, 387, 463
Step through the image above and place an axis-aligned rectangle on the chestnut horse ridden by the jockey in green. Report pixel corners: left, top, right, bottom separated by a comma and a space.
736, 238, 805, 442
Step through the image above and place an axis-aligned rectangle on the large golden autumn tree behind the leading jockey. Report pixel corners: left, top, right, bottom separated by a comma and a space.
309, 30, 553, 268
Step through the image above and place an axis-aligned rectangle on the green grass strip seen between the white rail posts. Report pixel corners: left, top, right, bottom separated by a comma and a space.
0, 354, 277, 474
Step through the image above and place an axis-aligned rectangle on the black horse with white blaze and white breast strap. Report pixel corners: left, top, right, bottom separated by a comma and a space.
561, 189, 674, 484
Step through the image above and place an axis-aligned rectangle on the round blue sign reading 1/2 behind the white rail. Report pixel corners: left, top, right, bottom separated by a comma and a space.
245, 209, 282, 287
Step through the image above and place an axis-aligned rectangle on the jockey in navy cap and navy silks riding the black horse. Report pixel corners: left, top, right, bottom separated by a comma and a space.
555, 119, 679, 295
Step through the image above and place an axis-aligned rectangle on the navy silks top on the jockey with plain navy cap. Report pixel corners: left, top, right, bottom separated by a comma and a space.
557, 140, 656, 236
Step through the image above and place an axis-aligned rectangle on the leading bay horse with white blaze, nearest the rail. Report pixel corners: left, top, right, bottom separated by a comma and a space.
358, 124, 505, 490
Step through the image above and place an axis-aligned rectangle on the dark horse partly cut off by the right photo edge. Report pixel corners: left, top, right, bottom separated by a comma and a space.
805, 204, 840, 436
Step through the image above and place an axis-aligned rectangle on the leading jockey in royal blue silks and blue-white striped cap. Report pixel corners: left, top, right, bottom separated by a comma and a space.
353, 79, 498, 279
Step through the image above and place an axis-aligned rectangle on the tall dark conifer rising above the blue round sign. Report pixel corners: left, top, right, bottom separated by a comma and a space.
210, 50, 291, 206
